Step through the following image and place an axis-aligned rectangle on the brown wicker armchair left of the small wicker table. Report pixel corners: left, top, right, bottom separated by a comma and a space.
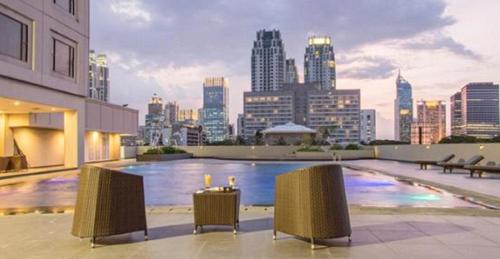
72, 166, 147, 247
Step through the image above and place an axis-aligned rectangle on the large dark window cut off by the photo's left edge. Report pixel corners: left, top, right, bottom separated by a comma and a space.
0, 13, 28, 62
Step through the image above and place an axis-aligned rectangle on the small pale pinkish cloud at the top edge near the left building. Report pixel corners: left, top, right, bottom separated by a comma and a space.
109, 0, 152, 24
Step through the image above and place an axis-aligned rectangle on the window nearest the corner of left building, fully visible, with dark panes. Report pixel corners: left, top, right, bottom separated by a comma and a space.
52, 38, 75, 78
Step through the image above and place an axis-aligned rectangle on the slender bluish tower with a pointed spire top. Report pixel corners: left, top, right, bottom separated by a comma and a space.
394, 73, 413, 143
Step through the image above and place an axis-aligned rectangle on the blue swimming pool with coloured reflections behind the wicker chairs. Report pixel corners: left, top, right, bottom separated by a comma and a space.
0, 159, 486, 209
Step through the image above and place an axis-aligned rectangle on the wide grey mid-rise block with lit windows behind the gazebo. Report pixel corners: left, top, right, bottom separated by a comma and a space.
243, 83, 360, 143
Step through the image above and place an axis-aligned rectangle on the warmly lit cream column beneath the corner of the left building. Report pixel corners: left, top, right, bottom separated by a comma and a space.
64, 111, 85, 167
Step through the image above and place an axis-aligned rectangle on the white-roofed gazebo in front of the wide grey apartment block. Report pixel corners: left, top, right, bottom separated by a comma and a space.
262, 122, 317, 145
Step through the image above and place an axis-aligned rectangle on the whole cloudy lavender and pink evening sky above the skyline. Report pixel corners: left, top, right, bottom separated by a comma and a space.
90, 0, 500, 139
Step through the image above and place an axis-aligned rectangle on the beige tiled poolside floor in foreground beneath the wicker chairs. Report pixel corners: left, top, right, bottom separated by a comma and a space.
0, 211, 500, 259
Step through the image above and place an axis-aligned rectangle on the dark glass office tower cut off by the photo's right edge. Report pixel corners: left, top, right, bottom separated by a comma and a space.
461, 83, 500, 138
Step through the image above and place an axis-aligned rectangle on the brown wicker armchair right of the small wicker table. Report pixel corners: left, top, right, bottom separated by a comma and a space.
273, 165, 351, 249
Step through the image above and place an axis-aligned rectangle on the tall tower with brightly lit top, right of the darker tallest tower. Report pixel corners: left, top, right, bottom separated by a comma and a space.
304, 37, 336, 89
